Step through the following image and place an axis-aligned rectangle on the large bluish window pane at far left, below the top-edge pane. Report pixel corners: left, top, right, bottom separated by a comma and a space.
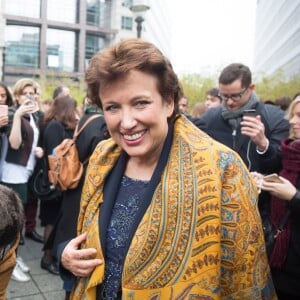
5, 25, 40, 68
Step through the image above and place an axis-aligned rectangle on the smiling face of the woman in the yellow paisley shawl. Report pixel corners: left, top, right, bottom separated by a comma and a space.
99, 70, 174, 162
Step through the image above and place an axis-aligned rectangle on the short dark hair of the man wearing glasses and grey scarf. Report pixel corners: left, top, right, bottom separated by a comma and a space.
219, 63, 252, 88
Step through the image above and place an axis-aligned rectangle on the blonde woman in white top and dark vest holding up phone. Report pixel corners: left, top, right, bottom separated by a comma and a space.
1, 78, 43, 282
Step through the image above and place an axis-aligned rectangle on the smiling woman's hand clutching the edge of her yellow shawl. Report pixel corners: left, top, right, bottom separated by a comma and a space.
61, 233, 103, 277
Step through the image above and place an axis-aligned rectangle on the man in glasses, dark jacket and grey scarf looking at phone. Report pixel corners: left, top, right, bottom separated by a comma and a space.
193, 63, 289, 174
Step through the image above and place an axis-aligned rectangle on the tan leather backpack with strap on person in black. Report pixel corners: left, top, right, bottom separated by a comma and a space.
48, 115, 102, 191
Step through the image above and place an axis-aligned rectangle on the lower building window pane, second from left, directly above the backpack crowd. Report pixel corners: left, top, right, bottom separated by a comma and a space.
47, 29, 78, 72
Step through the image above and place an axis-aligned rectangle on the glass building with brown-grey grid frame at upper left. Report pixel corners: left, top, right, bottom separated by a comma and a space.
1, 0, 117, 84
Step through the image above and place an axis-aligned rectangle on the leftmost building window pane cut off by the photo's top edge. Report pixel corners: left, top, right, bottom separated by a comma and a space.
4, 0, 41, 18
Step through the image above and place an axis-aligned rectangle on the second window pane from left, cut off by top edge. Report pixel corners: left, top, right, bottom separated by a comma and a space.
47, 0, 78, 24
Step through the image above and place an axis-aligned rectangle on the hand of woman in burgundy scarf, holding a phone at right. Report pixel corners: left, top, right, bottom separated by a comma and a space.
261, 176, 297, 201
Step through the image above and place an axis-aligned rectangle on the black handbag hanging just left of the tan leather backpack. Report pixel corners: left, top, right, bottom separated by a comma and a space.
29, 158, 62, 201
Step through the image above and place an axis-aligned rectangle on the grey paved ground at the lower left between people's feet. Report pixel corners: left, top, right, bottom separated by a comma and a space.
7, 228, 65, 300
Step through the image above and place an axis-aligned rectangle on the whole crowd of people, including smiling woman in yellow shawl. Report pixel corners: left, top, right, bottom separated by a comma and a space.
0, 39, 300, 300
